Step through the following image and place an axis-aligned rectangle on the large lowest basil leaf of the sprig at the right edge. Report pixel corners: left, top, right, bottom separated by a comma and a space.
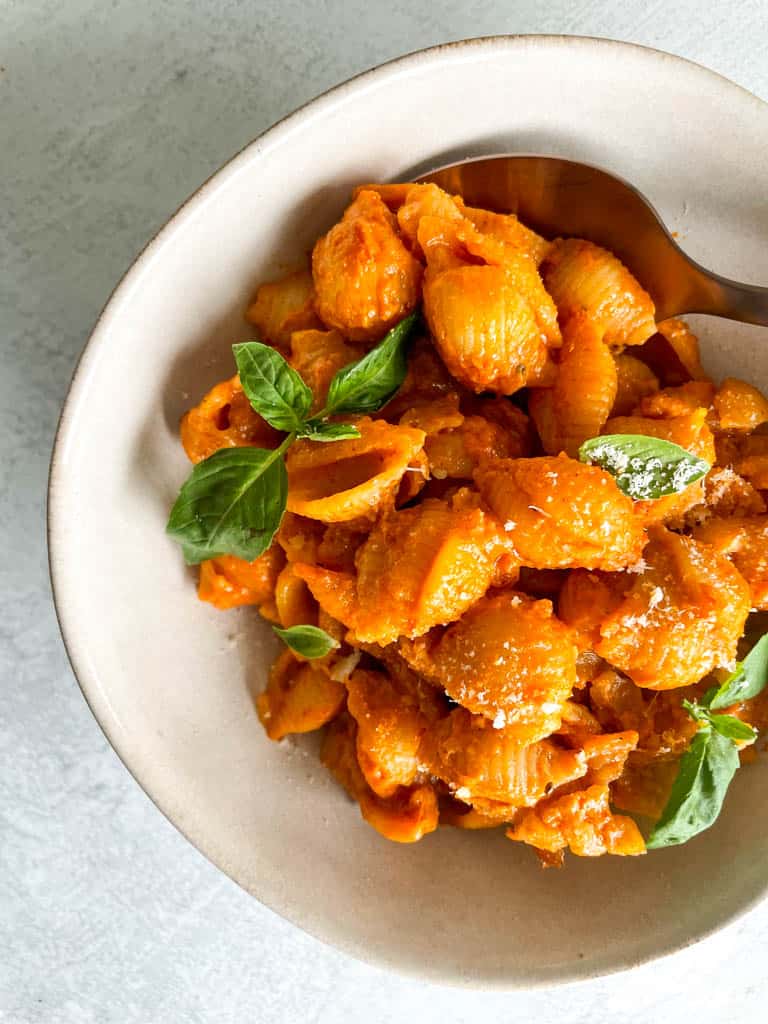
645, 725, 739, 850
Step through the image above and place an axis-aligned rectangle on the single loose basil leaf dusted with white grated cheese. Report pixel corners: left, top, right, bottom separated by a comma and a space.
579, 434, 712, 501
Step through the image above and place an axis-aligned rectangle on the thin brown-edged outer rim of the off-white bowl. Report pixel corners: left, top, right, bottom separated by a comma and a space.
46, 33, 768, 991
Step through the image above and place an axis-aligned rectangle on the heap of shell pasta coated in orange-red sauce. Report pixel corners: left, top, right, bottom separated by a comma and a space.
173, 183, 768, 867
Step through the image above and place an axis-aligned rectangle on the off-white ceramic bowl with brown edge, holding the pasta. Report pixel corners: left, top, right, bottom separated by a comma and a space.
49, 36, 768, 987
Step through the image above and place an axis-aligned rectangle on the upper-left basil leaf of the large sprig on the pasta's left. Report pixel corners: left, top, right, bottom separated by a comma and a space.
232, 341, 312, 431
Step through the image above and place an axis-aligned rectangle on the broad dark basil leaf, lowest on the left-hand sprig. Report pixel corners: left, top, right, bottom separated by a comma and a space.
166, 445, 288, 564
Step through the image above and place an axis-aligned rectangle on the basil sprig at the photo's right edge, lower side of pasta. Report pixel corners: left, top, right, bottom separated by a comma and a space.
646, 634, 768, 850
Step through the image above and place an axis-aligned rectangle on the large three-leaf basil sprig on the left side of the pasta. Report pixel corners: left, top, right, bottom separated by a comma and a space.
166, 313, 418, 565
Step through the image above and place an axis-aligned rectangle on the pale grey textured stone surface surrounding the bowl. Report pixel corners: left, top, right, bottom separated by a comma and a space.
0, 0, 768, 1024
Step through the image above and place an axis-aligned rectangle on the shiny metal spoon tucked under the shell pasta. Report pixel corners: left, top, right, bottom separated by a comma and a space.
418, 156, 768, 327
